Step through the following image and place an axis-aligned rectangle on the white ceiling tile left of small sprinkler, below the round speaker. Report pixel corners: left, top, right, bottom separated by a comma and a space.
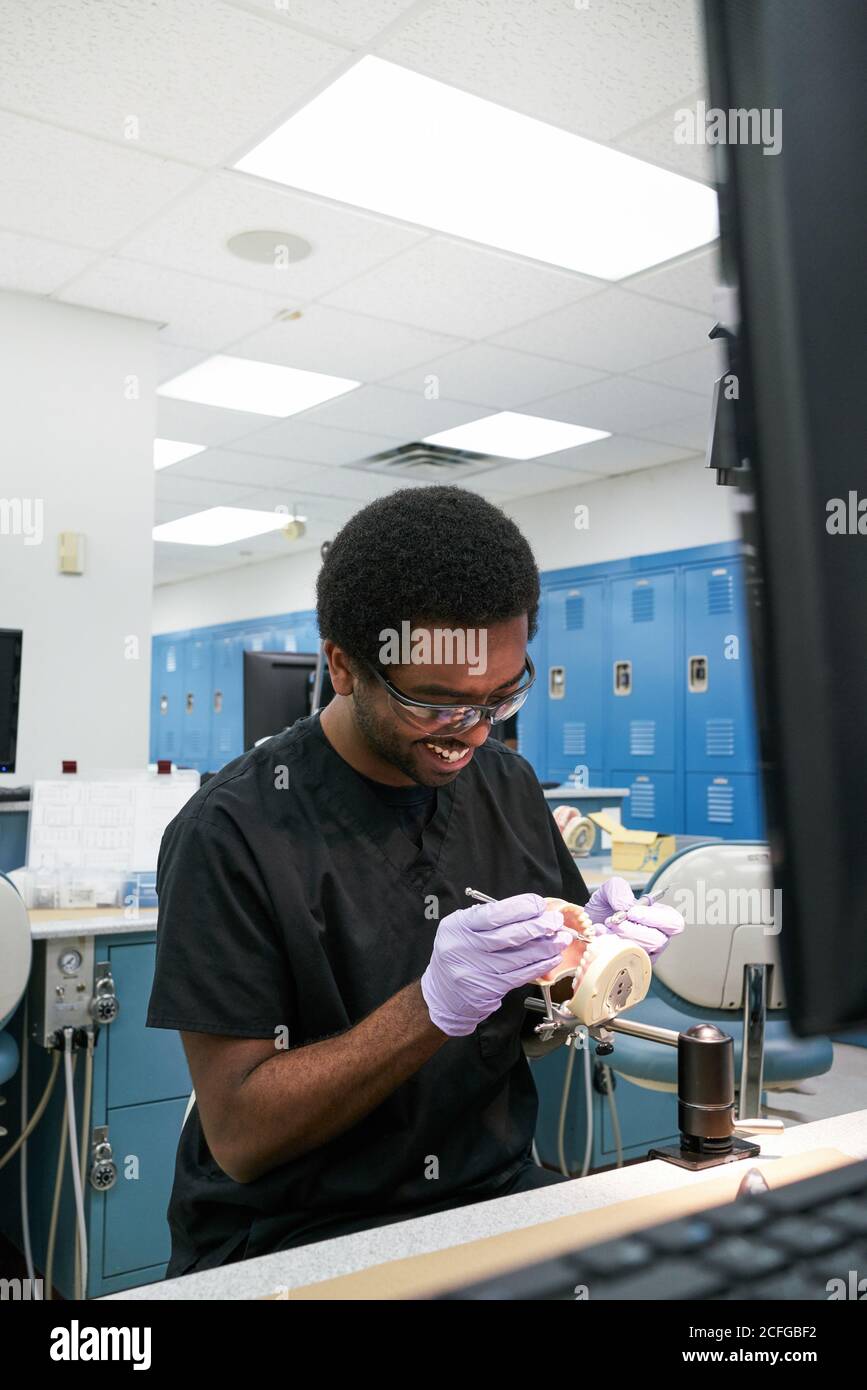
58, 257, 291, 352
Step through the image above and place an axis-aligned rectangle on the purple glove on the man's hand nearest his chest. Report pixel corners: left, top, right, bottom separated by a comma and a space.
421, 892, 574, 1037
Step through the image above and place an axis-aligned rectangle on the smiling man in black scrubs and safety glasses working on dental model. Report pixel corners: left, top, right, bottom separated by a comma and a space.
147, 487, 644, 1276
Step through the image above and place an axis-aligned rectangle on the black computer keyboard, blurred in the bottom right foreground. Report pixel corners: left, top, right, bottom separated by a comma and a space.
439, 1161, 867, 1302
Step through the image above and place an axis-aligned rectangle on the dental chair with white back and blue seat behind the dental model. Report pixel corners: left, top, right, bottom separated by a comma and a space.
607, 841, 834, 1118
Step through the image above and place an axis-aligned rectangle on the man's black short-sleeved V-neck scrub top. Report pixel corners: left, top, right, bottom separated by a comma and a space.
147, 714, 588, 1277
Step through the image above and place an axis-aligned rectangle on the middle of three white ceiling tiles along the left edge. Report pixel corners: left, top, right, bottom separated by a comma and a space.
0, 111, 200, 249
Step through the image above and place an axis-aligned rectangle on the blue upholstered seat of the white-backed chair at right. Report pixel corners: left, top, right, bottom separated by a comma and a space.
607, 979, 834, 1091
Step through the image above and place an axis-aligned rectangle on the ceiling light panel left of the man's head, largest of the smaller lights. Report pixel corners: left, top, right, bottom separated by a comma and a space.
157, 354, 361, 418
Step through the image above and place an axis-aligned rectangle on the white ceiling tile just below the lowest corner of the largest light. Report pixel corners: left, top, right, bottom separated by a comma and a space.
493, 289, 713, 373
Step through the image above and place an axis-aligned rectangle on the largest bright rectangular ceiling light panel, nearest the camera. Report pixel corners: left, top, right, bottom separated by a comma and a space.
235, 56, 718, 279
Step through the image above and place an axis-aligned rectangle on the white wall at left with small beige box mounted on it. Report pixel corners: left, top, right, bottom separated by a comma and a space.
0, 293, 156, 785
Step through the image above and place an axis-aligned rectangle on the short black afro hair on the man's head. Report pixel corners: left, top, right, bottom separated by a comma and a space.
317, 487, 539, 664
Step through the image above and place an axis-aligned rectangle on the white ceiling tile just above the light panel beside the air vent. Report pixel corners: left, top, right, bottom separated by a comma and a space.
383, 343, 600, 410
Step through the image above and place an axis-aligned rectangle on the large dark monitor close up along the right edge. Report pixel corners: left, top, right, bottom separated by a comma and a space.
704, 0, 867, 1036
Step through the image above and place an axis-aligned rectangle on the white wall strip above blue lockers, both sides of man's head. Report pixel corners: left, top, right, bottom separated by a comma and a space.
154, 457, 738, 632
